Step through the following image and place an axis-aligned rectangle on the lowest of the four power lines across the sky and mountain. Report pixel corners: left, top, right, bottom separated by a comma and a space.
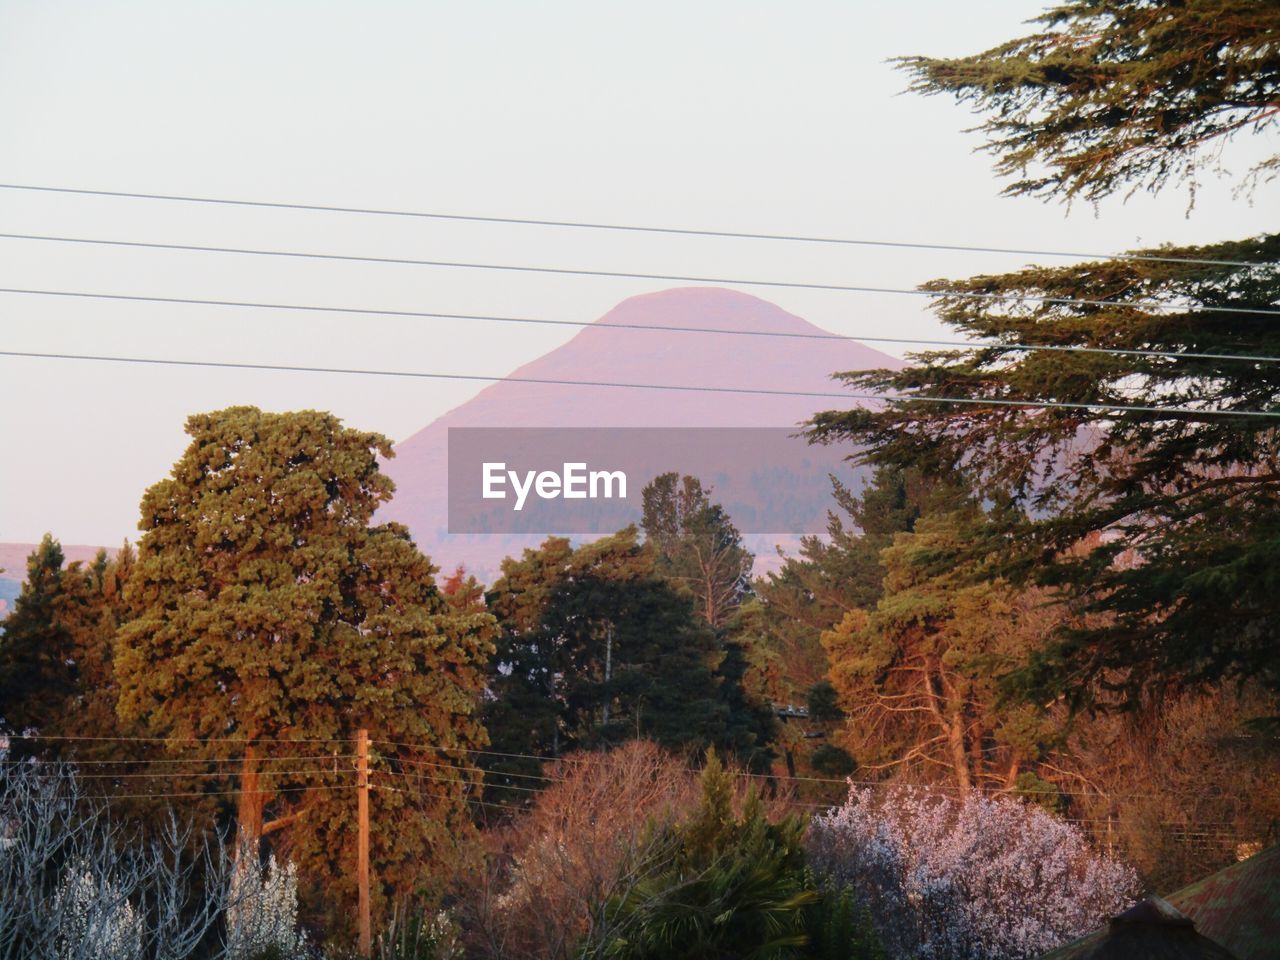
0, 349, 1280, 419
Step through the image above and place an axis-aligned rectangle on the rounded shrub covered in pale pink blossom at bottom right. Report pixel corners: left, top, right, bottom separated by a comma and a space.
808, 788, 1138, 960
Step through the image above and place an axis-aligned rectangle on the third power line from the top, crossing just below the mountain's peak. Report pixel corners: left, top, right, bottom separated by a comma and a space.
0, 287, 1280, 364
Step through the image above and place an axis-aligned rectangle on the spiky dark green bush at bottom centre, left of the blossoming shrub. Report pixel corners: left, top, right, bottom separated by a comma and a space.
584, 755, 818, 960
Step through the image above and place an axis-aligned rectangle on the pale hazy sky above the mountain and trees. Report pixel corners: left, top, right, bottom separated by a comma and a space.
0, 0, 1275, 544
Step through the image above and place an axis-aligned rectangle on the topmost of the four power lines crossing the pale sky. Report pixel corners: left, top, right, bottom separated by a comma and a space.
0, 183, 1256, 268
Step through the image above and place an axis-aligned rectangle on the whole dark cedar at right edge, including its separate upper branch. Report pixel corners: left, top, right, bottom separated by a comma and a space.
812, 0, 1280, 705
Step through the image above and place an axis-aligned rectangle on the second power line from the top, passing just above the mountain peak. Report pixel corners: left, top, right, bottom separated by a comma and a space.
0, 233, 1280, 316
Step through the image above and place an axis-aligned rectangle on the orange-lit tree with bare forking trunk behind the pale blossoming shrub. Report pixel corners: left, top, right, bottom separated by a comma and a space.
822, 506, 1057, 791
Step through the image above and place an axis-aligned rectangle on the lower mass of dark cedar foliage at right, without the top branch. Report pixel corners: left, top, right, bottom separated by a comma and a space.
813, 236, 1280, 699
